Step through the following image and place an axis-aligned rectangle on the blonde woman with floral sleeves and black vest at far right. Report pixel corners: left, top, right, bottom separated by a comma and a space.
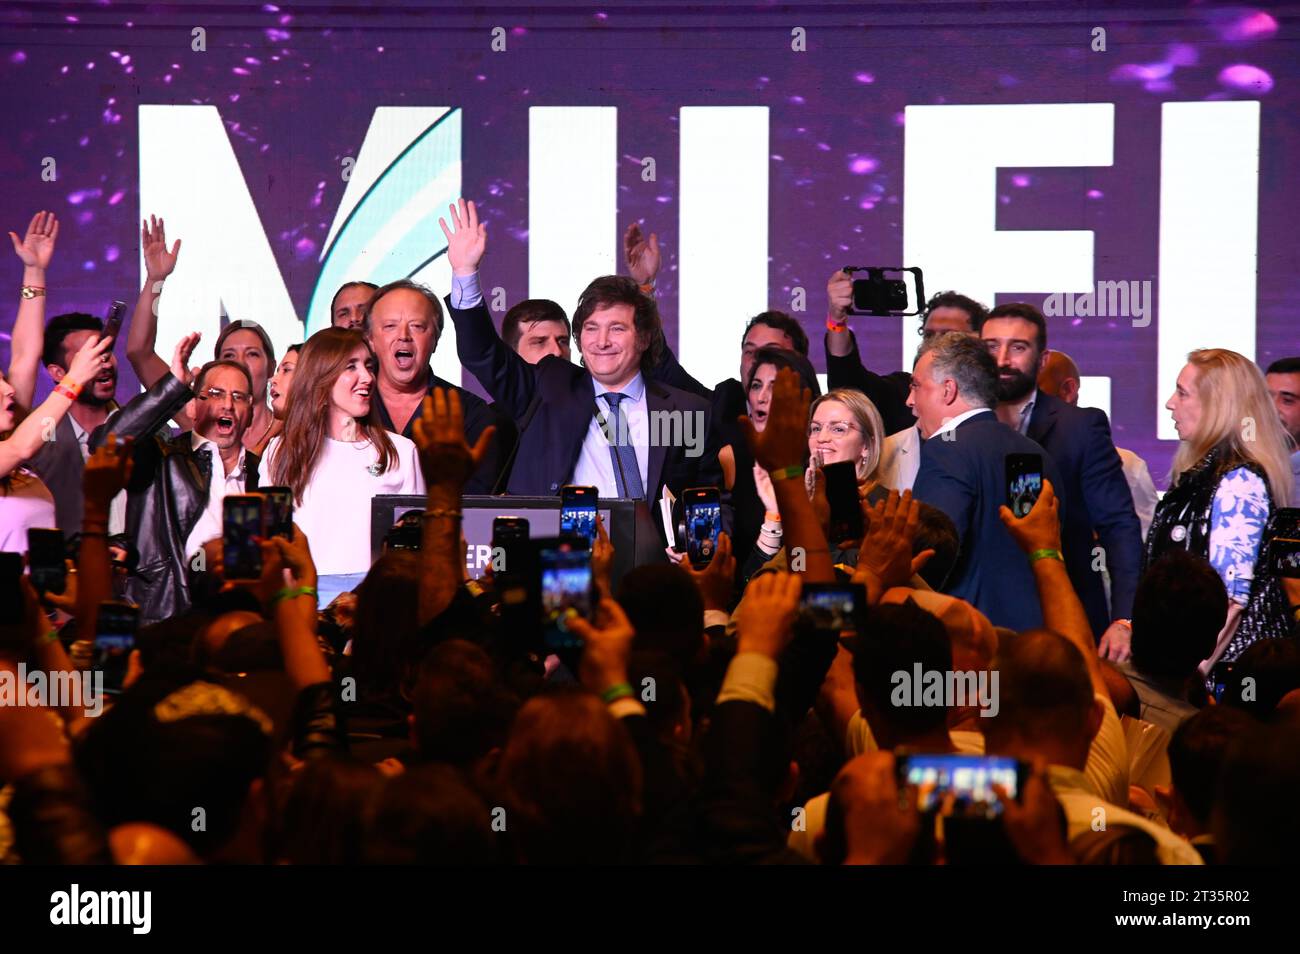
1145, 348, 1292, 675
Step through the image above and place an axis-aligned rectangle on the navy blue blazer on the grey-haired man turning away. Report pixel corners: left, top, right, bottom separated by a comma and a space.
911, 411, 1066, 630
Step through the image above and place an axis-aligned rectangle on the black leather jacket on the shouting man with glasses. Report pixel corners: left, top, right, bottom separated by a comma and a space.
91, 374, 257, 625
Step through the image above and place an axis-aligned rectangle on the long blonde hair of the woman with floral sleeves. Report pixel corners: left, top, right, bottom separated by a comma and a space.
1170, 348, 1292, 506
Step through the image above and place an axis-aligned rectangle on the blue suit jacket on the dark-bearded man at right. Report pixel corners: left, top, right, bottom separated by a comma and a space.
1028, 391, 1143, 637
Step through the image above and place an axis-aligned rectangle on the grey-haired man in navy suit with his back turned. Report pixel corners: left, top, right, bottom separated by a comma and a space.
907, 331, 1065, 630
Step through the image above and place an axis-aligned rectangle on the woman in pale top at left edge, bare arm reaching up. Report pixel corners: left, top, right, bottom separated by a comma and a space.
0, 338, 113, 552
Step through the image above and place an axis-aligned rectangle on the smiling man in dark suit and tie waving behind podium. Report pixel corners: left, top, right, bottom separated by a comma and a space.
442, 200, 729, 545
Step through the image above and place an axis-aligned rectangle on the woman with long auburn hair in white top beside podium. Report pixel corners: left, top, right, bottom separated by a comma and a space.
263, 328, 424, 576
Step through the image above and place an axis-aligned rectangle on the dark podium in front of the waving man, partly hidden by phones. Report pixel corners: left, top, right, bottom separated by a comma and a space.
371, 494, 668, 589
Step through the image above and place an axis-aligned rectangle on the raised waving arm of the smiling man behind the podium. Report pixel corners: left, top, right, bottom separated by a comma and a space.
438, 199, 537, 420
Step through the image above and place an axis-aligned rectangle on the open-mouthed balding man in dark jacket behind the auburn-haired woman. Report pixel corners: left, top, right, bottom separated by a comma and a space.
364, 279, 515, 494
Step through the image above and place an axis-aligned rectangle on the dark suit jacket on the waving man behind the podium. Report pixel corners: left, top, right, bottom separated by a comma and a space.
446, 296, 731, 529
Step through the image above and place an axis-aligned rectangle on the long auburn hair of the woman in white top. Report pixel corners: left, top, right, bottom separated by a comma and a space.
272, 328, 398, 506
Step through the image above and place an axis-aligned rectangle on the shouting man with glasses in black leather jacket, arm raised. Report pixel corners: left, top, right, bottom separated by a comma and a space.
91, 334, 259, 625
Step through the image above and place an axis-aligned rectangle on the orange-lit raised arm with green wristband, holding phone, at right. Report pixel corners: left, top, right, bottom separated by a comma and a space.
997, 480, 1110, 697
